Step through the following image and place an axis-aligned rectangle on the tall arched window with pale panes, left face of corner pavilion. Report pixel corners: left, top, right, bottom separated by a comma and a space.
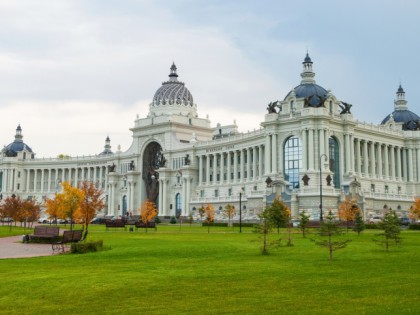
283, 136, 302, 188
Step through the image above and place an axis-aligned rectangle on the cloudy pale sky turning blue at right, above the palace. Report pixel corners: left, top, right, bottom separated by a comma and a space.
0, 0, 420, 158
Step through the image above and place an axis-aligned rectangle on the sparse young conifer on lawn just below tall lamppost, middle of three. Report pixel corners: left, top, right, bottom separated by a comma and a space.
314, 211, 351, 260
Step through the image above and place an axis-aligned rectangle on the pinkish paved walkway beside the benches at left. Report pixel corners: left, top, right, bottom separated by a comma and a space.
0, 235, 57, 259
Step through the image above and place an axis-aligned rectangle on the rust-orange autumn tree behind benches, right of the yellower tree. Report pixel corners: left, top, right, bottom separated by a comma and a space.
74, 181, 105, 239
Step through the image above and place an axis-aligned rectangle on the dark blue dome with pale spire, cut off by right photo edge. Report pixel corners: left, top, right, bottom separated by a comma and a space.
381, 84, 420, 130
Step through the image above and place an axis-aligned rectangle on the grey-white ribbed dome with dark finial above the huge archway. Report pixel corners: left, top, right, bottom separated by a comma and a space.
153, 63, 194, 106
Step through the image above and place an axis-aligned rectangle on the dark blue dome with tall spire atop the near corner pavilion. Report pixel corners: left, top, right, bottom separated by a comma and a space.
284, 53, 328, 107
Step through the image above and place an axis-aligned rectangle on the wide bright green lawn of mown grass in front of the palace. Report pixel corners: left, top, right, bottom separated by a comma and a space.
0, 225, 420, 314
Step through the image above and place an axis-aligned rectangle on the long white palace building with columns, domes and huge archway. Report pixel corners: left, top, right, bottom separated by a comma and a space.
0, 54, 420, 220
